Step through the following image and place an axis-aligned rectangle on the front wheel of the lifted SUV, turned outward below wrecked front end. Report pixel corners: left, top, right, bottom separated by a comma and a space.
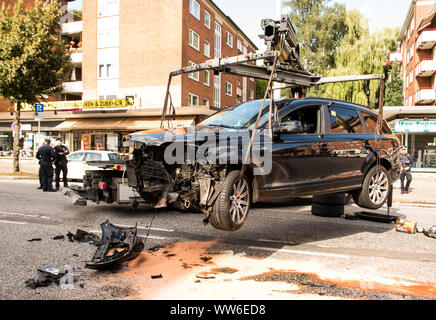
209, 170, 251, 232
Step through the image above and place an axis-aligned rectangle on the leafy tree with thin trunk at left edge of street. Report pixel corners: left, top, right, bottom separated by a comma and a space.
0, 0, 72, 172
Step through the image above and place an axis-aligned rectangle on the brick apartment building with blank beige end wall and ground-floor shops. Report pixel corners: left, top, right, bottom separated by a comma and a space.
0, 0, 257, 152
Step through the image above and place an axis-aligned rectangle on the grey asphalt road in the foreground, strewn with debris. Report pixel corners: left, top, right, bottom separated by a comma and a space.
0, 181, 436, 299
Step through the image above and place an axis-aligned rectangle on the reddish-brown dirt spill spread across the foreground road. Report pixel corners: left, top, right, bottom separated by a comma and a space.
106, 241, 436, 300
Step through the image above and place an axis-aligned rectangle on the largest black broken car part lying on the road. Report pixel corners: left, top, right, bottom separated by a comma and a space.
86, 221, 144, 270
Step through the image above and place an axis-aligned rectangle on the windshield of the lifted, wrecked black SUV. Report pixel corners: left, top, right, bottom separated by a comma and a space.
199, 100, 285, 129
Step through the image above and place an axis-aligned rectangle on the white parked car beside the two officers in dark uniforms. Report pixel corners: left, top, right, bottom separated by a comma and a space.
67, 151, 121, 180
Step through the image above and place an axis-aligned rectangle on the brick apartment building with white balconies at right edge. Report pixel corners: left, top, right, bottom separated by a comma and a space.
384, 0, 436, 172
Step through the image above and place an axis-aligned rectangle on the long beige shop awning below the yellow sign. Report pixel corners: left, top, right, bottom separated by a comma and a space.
53, 116, 195, 131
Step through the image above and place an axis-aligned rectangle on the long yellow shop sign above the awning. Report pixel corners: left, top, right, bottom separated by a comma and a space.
22, 97, 134, 111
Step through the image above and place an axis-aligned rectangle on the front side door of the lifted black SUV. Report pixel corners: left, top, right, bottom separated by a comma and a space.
269, 105, 328, 199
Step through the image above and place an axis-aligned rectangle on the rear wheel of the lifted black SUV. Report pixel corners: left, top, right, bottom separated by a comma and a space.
353, 166, 392, 210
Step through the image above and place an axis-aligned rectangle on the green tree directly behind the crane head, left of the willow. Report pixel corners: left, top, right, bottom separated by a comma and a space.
285, 0, 348, 73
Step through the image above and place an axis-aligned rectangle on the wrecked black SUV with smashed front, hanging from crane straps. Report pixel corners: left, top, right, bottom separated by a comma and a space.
123, 98, 400, 231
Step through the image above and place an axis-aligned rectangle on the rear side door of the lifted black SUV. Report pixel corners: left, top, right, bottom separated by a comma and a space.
321, 103, 368, 187
